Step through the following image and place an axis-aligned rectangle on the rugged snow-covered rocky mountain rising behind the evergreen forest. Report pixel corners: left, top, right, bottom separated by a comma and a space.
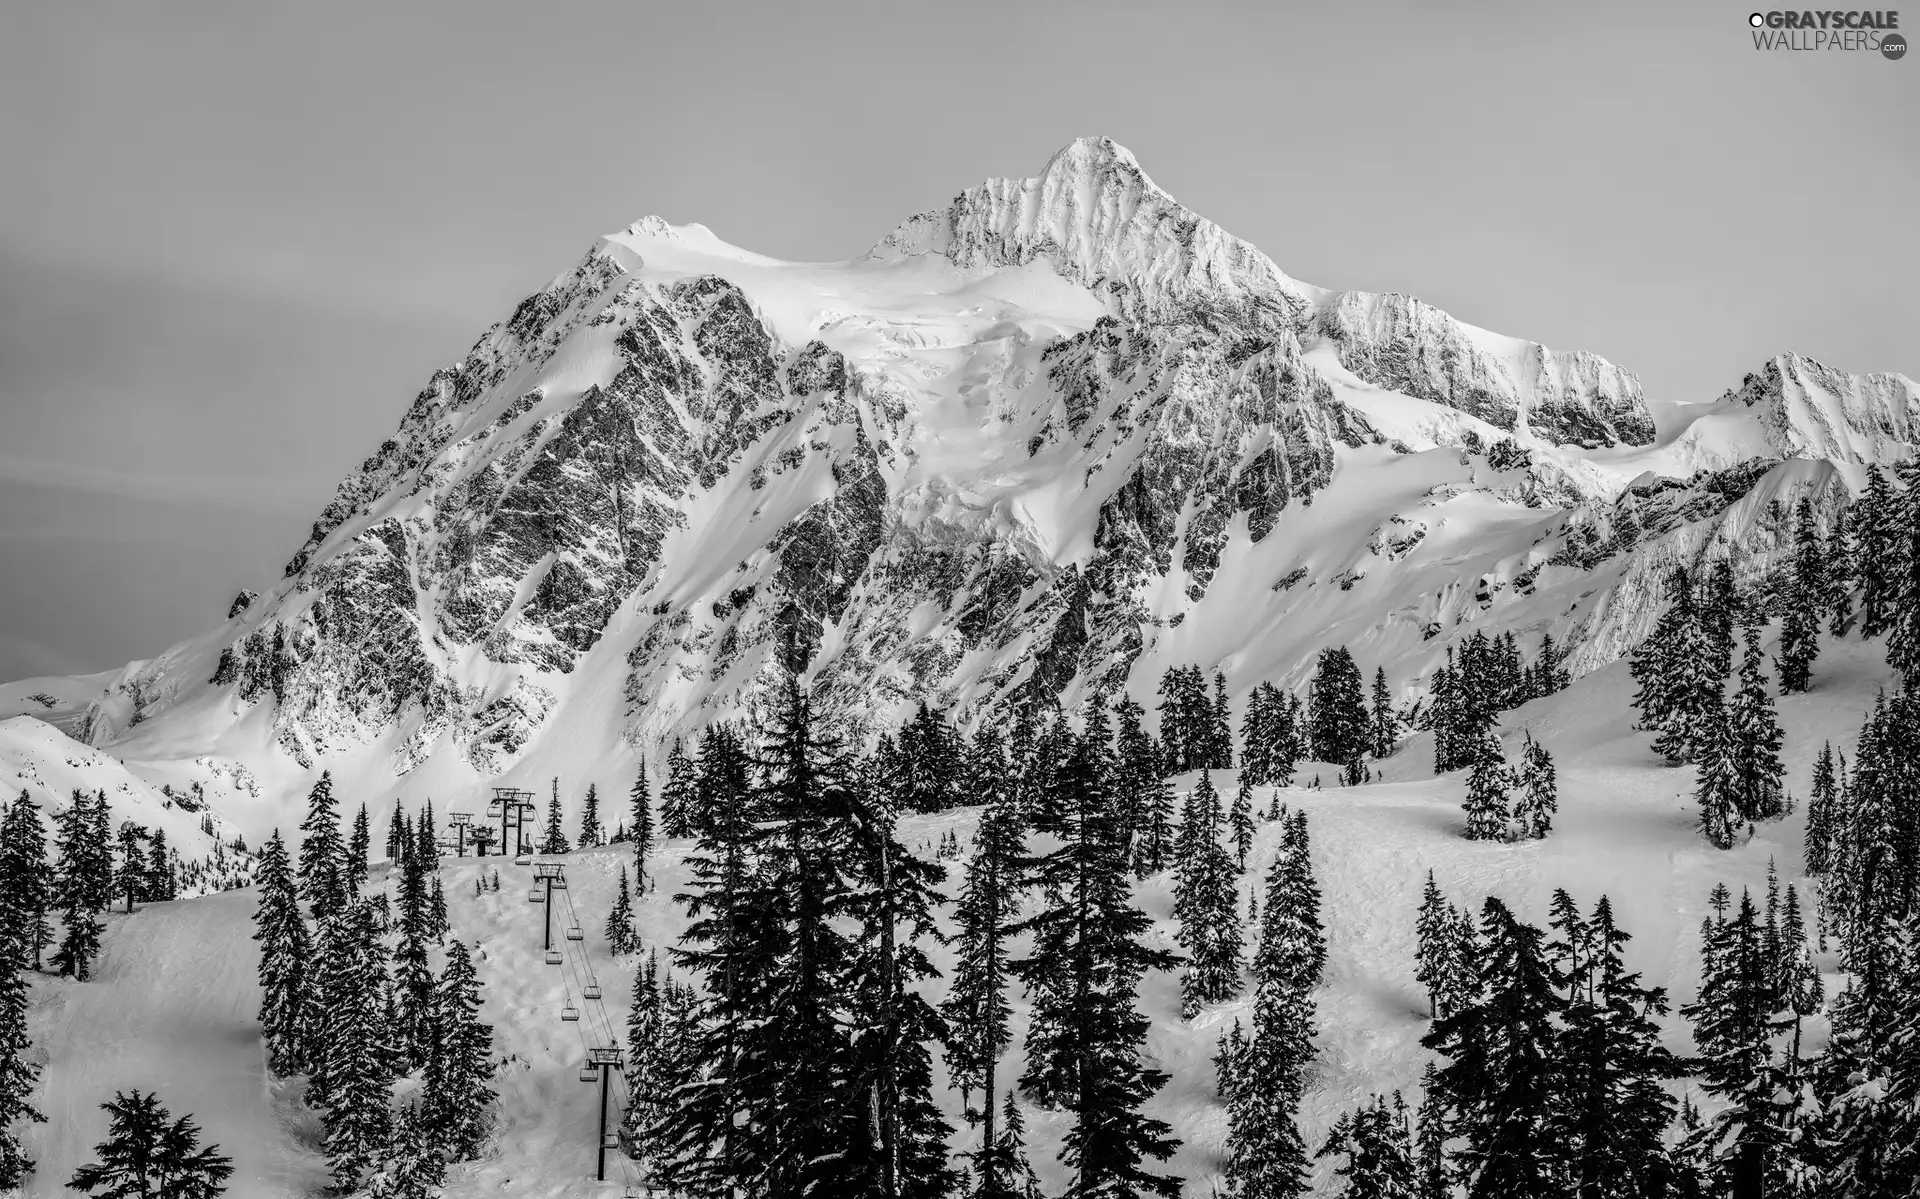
0, 138, 1920, 836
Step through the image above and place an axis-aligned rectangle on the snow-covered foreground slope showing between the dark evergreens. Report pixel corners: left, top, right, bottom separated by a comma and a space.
27, 640, 1889, 1199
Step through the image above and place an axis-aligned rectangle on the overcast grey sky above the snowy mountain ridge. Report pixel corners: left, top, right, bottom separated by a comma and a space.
0, 0, 1920, 678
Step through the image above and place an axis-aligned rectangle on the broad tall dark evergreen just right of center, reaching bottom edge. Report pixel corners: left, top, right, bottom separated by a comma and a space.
1008, 714, 1179, 1197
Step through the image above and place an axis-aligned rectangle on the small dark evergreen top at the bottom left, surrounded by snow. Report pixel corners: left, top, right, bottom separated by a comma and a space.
67, 1091, 234, 1199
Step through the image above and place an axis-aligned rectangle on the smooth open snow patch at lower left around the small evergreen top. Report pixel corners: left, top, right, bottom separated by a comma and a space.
25, 890, 326, 1199
